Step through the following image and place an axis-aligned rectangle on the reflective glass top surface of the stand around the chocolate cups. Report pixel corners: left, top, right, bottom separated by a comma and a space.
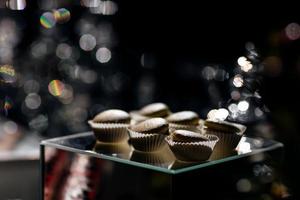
44, 132, 282, 174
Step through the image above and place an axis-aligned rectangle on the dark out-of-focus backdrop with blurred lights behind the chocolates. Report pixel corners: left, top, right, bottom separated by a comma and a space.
0, 0, 300, 196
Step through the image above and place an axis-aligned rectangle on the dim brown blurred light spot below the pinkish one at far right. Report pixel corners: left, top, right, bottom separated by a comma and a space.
263, 56, 282, 77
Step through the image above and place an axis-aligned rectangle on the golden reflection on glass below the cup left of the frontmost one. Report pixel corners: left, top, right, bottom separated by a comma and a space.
130, 150, 173, 168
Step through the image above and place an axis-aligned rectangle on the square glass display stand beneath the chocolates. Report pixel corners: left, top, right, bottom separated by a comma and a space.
41, 132, 283, 200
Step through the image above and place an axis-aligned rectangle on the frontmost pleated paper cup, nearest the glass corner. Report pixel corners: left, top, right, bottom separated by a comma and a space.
165, 135, 219, 162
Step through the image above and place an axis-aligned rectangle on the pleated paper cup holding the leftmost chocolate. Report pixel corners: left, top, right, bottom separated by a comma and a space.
89, 121, 129, 143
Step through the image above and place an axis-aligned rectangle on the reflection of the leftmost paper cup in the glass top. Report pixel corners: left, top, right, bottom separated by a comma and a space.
93, 142, 132, 158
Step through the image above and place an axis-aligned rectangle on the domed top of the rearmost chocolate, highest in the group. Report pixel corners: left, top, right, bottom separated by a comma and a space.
139, 103, 170, 117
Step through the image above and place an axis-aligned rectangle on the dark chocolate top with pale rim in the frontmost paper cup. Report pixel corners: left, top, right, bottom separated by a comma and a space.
171, 130, 208, 142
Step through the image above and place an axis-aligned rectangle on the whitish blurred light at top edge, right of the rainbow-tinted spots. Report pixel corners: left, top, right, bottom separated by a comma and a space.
90, 0, 118, 15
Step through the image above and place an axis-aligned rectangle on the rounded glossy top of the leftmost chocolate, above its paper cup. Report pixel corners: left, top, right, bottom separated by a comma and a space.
93, 109, 130, 124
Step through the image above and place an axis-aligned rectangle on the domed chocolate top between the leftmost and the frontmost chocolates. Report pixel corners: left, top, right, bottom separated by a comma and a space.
131, 117, 169, 135
